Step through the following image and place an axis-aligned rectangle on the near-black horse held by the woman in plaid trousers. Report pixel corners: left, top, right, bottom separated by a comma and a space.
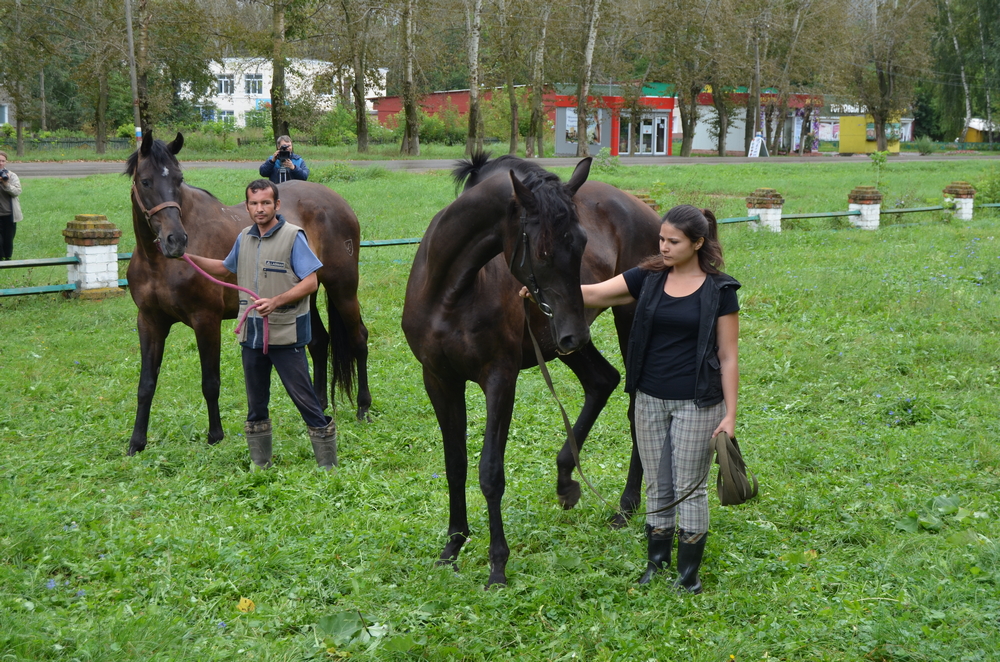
403, 154, 660, 585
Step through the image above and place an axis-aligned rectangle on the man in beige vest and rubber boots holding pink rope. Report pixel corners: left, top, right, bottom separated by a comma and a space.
182, 179, 337, 471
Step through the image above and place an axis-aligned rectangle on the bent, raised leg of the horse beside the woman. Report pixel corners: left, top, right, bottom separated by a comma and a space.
556, 343, 621, 510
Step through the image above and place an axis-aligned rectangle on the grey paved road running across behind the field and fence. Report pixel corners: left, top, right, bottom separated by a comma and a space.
11, 153, 1000, 179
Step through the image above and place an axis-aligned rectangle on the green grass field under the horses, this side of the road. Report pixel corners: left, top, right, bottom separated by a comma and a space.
0, 161, 1000, 662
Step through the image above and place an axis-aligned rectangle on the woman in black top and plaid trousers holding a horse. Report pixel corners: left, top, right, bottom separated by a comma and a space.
583, 205, 740, 593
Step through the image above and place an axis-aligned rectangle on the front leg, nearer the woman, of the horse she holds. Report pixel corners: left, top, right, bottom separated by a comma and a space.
479, 368, 517, 588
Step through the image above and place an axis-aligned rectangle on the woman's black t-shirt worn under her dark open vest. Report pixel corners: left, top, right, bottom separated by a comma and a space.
622, 267, 740, 400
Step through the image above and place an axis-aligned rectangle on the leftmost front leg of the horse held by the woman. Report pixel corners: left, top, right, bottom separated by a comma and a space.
424, 367, 469, 570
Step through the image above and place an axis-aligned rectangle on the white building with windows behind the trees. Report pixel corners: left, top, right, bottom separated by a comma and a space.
201, 57, 387, 126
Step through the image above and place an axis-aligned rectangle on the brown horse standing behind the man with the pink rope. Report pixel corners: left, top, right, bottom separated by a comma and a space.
126, 133, 371, 455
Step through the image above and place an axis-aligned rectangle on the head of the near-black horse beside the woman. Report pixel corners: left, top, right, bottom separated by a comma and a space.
505, 158, 591, 354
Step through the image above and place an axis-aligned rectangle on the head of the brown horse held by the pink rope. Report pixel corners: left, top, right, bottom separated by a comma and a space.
125, 132, 188, 257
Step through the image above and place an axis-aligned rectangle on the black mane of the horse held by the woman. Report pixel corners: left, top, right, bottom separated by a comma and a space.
452, 151, 576, 253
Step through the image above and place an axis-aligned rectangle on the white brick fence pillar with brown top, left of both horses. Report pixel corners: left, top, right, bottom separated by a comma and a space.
63, 214, 122, 299
